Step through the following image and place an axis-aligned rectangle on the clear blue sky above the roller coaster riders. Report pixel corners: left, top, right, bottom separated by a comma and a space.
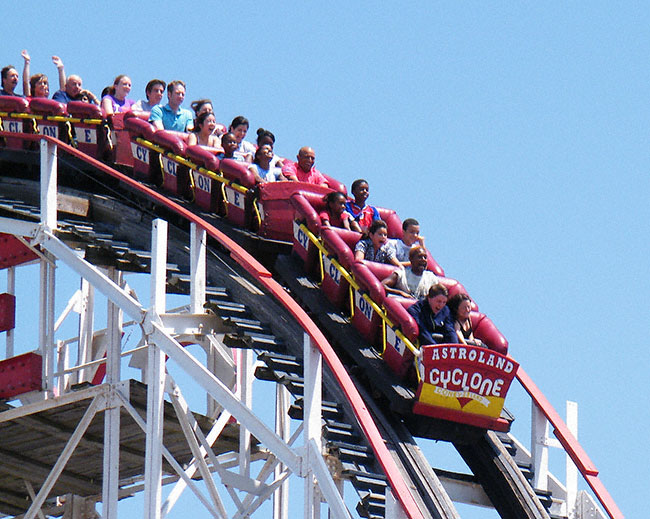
5, 1, 650, 518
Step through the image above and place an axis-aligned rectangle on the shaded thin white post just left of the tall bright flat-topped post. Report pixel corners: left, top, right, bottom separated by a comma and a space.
102, 268, 122, 519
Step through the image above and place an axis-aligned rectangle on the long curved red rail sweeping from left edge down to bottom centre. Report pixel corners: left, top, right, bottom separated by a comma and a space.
0, 132, 423, 519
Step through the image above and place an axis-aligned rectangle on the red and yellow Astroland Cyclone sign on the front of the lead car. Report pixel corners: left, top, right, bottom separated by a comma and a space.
418, 344, 519, 418
